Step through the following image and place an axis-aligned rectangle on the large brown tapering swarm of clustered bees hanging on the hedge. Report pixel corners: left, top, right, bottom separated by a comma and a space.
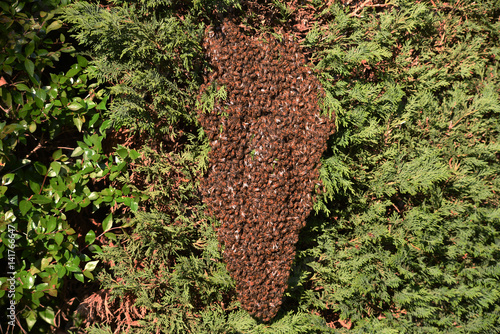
199, 22, 333, 321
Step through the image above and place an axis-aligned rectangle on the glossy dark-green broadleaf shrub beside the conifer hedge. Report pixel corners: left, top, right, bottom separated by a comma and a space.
0, 1, 140, 333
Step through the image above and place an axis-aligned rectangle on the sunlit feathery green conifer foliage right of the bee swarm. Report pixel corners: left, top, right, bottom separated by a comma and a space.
305, 1, 500, 333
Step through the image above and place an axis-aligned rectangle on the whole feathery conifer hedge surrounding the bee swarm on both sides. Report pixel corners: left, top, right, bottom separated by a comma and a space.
51, 0, 500, 333
